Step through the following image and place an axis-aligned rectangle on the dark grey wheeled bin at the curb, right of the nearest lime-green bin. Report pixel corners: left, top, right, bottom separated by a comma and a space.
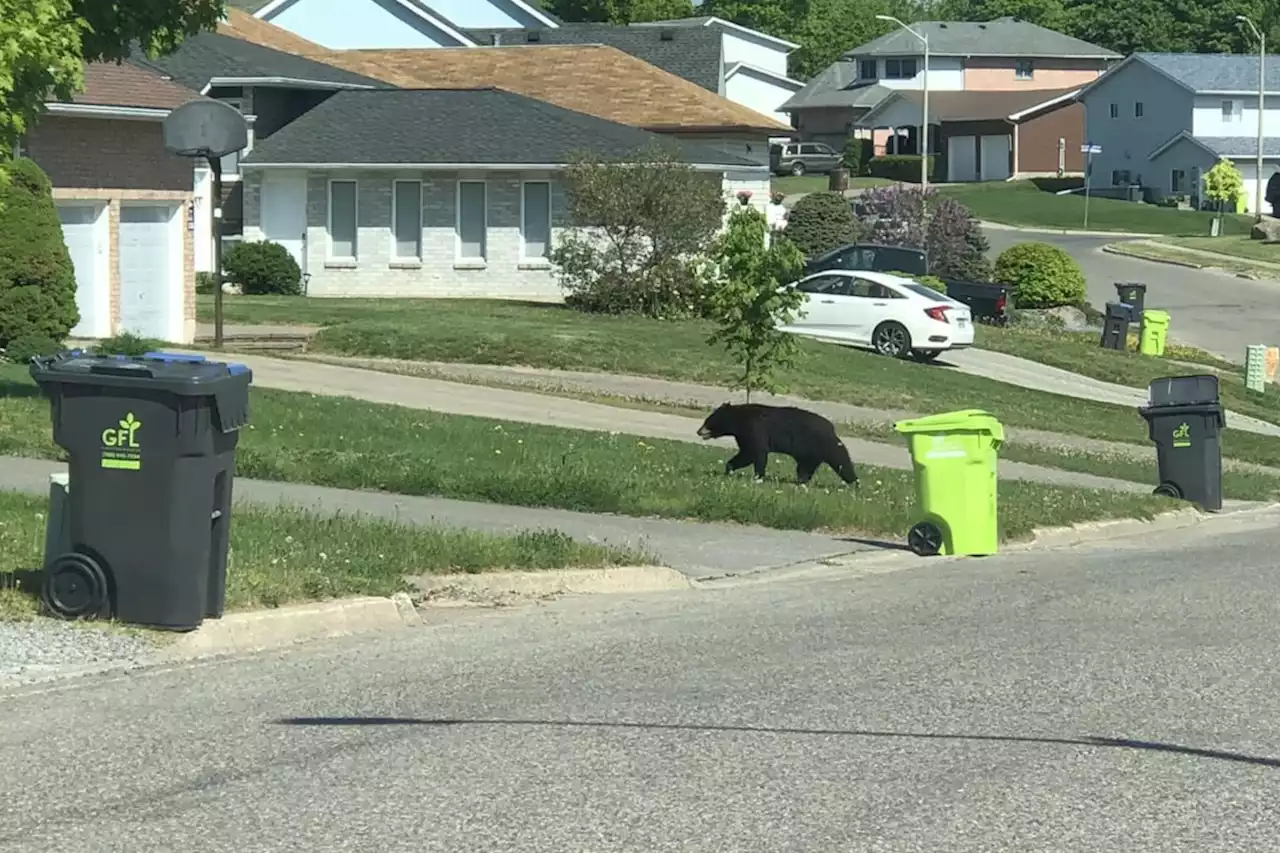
1138, 374, 1226, 504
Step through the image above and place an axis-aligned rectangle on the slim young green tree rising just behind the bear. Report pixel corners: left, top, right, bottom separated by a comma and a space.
708, 207, 804, 402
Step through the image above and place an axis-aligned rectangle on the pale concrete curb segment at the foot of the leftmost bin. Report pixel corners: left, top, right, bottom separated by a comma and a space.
157, 593, 422, 661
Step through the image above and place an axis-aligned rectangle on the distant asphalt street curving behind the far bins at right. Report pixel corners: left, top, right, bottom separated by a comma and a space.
986, 228, 1280, 362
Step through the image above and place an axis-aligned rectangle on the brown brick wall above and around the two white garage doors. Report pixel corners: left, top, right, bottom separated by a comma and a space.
27, 115, 196, 343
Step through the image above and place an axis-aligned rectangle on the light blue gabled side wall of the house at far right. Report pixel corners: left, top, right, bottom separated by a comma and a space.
1082, 60, 1193, 187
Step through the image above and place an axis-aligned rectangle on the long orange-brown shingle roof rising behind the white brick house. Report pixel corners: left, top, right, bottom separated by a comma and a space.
303, 45, 791, 132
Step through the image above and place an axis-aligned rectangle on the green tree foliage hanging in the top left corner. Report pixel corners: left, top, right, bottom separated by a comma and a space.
0, 0, 224, 151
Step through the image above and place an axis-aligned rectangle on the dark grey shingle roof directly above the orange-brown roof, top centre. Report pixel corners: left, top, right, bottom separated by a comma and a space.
465, 23, 724, 92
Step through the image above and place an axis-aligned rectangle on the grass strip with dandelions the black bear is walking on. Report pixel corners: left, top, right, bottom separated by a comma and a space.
0, 366, 1172, 537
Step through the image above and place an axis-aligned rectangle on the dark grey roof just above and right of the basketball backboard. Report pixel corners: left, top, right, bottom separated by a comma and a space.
132, 32, 388, 92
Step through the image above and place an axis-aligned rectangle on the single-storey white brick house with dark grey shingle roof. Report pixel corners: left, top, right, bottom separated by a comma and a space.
241, 87, 769, 300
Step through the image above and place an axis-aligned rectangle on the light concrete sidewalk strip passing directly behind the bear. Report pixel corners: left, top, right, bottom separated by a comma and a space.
185, 355, 1151, 493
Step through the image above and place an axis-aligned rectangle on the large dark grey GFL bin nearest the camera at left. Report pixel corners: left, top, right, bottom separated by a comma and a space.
31, 351, 252, 630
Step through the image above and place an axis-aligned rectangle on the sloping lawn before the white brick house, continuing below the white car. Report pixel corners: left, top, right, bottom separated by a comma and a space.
202, 297, 1280, 465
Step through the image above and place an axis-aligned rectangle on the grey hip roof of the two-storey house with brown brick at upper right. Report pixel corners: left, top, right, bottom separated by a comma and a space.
845, 18, 1120, 59
